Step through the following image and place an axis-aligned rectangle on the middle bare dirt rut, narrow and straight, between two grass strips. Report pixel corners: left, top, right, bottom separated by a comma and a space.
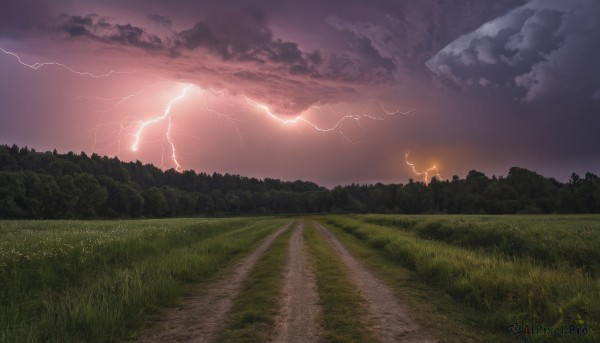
275, 223, 322, 343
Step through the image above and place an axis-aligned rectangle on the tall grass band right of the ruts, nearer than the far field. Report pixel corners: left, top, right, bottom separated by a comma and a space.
326, 216, 600, 341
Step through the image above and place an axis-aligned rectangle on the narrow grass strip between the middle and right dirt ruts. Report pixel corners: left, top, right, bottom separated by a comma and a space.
304, 225, 375, 342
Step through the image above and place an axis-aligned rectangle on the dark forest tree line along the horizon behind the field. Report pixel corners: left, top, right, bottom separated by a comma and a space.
0, 145, 600, 219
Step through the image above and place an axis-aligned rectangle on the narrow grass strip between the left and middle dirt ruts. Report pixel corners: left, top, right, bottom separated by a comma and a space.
217, 224, 296, 342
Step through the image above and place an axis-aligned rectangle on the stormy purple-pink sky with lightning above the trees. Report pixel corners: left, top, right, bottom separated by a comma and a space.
0, 0, 600, 187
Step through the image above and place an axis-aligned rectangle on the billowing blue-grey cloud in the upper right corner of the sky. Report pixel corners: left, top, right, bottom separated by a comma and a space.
429, 1, 600, 102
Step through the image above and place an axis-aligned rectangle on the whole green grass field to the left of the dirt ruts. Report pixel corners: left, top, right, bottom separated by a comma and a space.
0, 218, 284, 342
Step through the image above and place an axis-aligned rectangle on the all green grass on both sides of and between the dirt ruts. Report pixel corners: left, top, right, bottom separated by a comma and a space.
0, 215, 600, 342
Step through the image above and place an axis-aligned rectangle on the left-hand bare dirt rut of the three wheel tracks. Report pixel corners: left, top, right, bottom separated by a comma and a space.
138, 223, 291, 342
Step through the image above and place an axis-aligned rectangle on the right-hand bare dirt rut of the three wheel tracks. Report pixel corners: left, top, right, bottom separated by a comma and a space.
316, 224, 436, 342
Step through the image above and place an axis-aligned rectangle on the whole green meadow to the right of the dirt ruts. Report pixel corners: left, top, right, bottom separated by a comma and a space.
323, 215, 600, 341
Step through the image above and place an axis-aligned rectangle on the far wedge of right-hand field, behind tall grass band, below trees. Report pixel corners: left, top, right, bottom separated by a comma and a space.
355, 215, 600, 276
